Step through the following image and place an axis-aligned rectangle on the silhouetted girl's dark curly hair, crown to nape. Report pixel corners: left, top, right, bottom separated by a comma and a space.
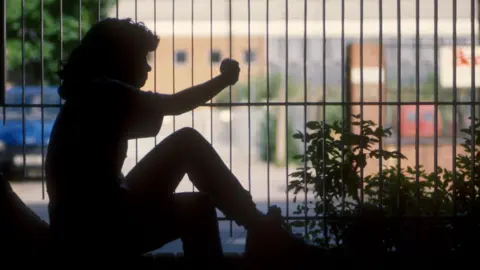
58, 18, 159, 100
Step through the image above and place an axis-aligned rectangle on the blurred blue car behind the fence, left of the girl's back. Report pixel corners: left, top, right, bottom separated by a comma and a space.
0, 86, 62, 180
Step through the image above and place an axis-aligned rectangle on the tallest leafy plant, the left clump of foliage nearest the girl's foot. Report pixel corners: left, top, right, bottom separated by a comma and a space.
288, 115, 404, 245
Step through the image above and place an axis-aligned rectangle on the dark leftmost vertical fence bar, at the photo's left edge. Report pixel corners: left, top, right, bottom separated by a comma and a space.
0, 0, 7, 106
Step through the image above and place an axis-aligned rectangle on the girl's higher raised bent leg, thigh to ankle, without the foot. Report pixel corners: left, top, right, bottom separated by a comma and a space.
126, 128, 263, 227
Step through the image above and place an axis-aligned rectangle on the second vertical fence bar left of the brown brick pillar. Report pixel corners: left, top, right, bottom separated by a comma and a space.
320, 0, 328, 240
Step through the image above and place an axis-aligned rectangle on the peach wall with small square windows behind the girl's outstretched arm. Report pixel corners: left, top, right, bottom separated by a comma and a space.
144, 36, 266, 99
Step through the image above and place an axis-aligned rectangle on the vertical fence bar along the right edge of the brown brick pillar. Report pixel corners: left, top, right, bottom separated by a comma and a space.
378, 0, 384, 210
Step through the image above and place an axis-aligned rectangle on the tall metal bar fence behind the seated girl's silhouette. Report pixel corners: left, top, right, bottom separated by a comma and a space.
0, 0, 479, 248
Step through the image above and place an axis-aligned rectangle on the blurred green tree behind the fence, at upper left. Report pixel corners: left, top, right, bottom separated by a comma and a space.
6, 0, 115, 85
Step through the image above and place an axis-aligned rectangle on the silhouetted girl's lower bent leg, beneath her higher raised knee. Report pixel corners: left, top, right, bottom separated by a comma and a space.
129, 192, 223, 266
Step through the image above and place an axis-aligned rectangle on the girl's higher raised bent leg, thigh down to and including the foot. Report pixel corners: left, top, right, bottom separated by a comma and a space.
127, 128, 318, 264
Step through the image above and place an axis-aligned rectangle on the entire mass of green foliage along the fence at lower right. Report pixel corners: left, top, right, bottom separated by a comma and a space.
288, 115, 480, 253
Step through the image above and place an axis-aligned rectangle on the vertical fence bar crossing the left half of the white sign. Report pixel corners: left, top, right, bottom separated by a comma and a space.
452, 0, 457, 217
